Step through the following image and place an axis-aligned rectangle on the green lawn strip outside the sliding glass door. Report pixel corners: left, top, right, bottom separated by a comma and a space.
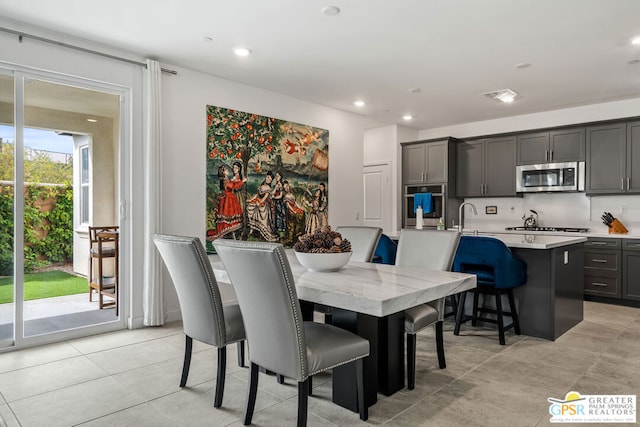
0, 271, 89, 304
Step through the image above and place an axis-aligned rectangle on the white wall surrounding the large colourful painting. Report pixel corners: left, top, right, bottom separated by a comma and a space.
162, 65, 364, 319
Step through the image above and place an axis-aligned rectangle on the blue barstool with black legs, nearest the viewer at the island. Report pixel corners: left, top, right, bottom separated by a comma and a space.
453, 236, 527, 345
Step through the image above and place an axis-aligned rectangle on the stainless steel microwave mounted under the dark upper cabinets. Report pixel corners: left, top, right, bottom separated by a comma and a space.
516, 162, 584, 193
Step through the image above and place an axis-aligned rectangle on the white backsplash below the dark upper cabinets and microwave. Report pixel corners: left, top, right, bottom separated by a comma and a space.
460, 193, 640, 235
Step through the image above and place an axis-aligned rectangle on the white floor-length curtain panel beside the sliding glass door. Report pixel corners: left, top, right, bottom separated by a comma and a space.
143, 59, 164, 326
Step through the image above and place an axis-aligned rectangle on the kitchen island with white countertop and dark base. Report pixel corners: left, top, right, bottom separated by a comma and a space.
468, 233, 587, 340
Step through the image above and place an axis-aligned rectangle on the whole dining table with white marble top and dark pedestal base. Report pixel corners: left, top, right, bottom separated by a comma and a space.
209, 249, 476, 412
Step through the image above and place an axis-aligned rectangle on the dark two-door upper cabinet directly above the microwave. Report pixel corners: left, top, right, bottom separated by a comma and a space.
516, 127, 585, 165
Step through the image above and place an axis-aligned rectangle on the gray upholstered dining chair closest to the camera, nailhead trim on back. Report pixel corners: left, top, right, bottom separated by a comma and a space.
213, 239, 369, 426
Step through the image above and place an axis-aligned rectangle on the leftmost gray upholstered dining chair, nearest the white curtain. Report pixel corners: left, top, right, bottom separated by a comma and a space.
153, 234, 245, 408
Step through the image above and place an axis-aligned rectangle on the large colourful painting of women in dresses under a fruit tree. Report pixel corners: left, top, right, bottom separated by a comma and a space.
206, 105, 329, 251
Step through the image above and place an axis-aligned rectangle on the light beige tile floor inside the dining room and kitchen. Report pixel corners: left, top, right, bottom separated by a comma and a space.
0, 302, 640, 427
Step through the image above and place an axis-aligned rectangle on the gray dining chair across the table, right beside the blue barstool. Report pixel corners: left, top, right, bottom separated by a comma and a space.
396, 229, 460, 390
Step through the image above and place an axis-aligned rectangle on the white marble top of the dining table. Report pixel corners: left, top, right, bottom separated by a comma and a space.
209, 250, 476, 317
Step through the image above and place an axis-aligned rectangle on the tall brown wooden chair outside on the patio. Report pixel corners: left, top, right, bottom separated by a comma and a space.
88, 226, 120, 316
